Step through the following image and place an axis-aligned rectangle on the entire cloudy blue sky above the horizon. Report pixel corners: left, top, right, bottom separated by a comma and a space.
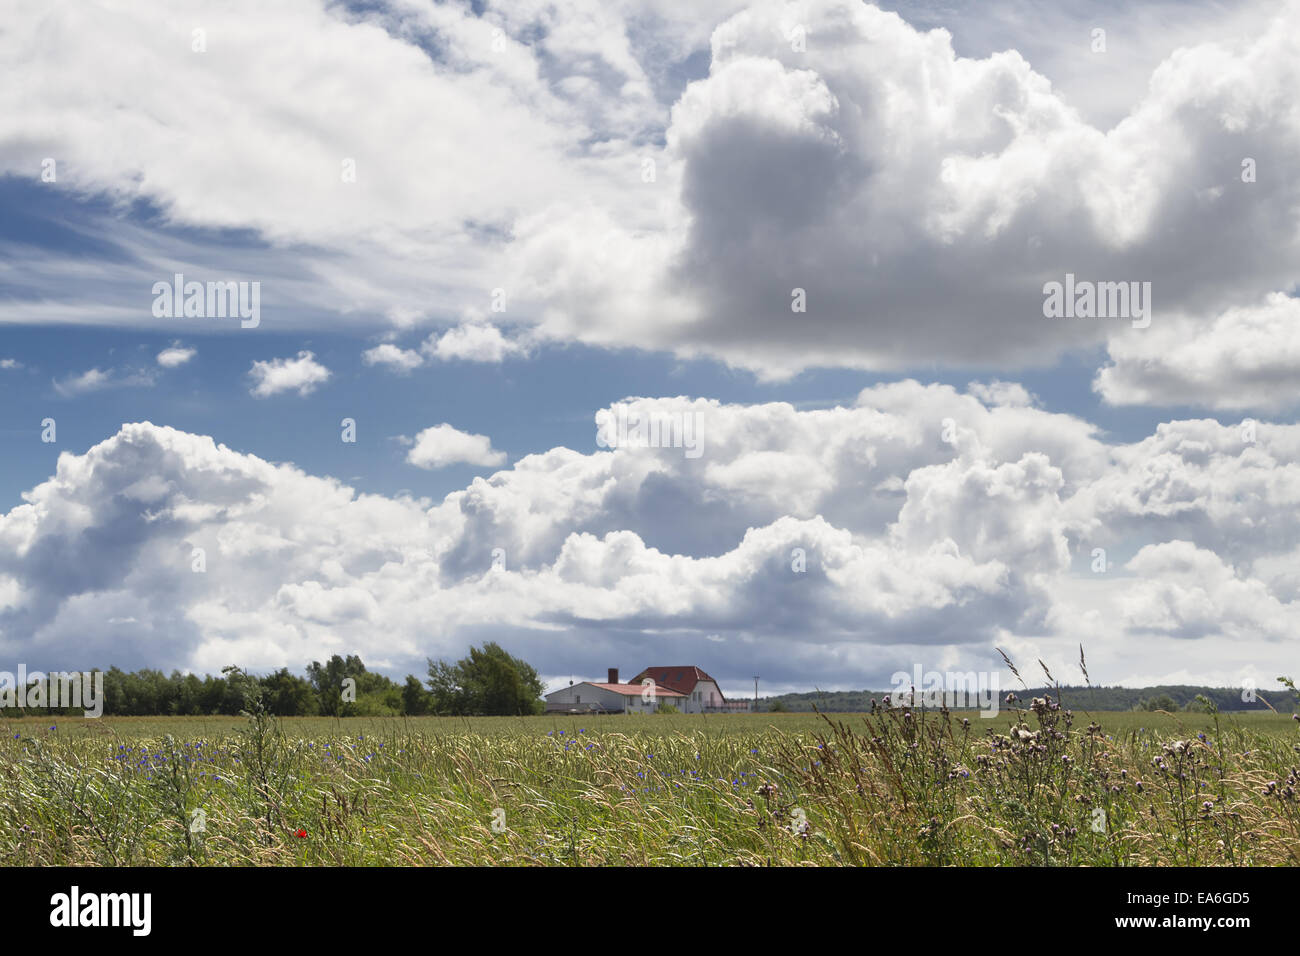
0, 0, 1300, 696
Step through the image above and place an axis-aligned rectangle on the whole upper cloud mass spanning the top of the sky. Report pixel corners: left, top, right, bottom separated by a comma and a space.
0, 0, 1300, 408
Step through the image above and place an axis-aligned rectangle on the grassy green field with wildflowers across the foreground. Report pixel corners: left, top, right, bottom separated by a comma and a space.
0, 700, 1300, 865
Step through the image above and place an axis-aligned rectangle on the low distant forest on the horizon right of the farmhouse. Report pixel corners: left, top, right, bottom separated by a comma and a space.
759, 684, 1295, 714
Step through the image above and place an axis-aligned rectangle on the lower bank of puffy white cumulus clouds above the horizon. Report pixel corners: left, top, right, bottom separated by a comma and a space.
0, 381, 1300, 685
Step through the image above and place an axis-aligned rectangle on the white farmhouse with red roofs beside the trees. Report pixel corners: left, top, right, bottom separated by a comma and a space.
546, 667, 750, 714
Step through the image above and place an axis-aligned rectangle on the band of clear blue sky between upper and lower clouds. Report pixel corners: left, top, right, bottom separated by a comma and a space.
0, 165, 1196, 507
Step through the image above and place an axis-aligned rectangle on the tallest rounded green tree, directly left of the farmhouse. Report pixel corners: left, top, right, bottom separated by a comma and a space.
429, 641, 543, 717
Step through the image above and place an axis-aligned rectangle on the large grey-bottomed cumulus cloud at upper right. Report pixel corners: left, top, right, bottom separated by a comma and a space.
512, 0, 1300, 385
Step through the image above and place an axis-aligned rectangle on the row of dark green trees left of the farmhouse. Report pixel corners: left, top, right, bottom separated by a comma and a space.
6, 641, 545, 717
